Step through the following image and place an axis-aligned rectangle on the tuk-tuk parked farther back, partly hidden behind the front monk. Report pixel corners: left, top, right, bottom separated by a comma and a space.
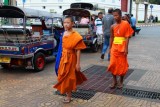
63, 3, 99, 52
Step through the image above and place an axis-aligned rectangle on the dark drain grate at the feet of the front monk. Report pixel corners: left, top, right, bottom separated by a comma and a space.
55, 89, 96, 100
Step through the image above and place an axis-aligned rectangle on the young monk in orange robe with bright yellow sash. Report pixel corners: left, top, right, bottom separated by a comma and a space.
108, 9, 133, 88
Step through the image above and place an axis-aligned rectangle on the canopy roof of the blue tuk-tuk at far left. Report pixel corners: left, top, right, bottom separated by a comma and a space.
0, 6, 61, 18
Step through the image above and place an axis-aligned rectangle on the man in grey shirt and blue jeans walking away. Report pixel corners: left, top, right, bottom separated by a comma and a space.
101, 8, 114, 60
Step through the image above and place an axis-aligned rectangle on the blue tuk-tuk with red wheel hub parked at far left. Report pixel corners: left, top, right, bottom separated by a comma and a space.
0, 6, 62, 71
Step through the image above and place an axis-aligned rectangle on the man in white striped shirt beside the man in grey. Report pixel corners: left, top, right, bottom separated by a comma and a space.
94, 12, 103, 46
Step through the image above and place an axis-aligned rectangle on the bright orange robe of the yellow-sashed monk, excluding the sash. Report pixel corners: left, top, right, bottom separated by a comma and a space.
108, 21, 133, 76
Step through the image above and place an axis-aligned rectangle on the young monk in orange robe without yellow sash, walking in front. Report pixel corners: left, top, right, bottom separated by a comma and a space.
54, 16, 87, 103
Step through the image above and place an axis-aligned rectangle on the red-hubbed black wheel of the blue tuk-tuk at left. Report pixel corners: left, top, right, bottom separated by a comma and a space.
33, 52, 46, 71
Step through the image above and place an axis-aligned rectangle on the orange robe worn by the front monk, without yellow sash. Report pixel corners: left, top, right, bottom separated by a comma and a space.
54, 31, 87, 94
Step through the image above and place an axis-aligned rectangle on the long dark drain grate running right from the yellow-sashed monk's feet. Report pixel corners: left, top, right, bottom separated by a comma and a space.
122, 88, 160, 100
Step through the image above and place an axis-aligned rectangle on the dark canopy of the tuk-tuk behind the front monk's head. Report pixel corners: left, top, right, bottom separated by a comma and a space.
63, 8, 98, 17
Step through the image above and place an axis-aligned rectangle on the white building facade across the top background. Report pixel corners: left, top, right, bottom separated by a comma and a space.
0, 0, 160, 21
